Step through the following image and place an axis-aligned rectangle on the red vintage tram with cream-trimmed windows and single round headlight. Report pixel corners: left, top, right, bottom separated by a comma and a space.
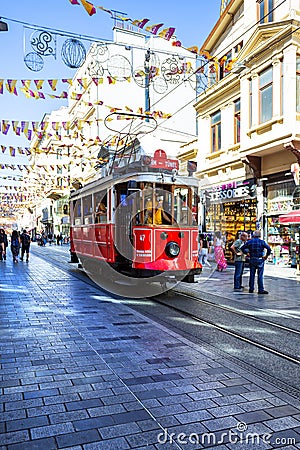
70, 146, 201, 297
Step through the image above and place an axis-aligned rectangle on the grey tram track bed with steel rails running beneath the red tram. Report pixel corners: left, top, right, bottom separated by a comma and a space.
34, 246, 300, 398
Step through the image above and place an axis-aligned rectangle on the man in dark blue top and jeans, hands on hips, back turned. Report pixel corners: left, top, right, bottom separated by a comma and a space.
241, 230, 271, 294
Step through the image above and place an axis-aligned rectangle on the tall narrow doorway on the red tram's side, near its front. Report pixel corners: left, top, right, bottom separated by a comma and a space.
114, 183, 134, 262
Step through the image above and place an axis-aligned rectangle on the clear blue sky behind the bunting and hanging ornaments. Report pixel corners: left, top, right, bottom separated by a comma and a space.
0, 0, 221, 192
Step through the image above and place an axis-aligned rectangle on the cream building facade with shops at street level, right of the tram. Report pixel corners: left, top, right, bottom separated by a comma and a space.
181, 0, 300, 264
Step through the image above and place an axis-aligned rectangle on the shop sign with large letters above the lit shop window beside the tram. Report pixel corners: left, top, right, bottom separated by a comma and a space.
206, 178, 256, 202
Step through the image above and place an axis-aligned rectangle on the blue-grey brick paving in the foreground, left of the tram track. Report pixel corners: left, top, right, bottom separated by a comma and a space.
0, 249, 300, 450
